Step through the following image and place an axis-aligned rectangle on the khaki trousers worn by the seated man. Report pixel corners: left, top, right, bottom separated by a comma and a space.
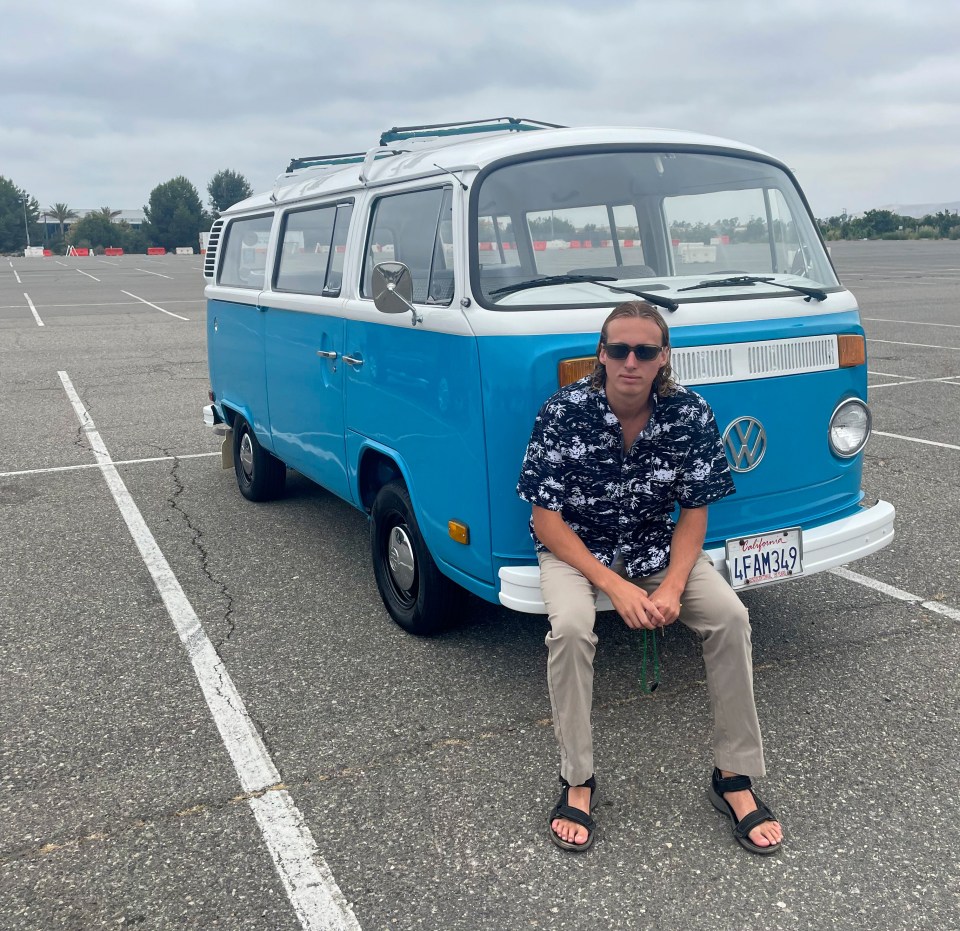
540, 553, 765, 785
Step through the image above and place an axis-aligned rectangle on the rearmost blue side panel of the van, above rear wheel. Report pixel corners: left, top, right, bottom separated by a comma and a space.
207, 300, 273, 451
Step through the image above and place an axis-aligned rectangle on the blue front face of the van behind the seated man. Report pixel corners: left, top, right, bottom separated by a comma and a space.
478, 310, 867, 570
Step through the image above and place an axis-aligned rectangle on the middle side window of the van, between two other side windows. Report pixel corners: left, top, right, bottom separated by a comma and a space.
274, 204, 353, 296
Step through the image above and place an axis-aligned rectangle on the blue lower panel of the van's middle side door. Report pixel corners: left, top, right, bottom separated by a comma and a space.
263, 307, 357, 504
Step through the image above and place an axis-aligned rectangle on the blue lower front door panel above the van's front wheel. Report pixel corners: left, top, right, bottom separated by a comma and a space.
344, 311, 496, 588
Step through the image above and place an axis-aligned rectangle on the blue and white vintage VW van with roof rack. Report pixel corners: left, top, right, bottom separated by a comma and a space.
204, 118, 894, 633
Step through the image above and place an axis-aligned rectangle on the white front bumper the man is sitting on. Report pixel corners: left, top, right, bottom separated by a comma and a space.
500, 501, 896, 614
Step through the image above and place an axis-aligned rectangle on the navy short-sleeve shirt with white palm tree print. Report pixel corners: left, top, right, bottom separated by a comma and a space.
517, 377, 735, 578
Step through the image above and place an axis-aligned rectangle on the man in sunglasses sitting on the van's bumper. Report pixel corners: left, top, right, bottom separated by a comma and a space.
517, 301, 783, 854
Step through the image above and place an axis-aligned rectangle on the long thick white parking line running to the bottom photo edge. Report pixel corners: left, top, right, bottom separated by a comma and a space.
57, 372, 360, 931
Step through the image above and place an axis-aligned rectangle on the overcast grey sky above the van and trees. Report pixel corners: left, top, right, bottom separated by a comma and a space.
0, 0, 960, 217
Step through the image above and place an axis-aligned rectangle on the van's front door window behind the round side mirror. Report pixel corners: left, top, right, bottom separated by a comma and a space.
360, 187, 453, 304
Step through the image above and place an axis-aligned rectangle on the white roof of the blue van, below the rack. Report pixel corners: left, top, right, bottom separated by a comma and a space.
224, 118, 771, 214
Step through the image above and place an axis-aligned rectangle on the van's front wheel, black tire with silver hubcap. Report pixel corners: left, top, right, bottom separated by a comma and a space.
370, 482, 463, 636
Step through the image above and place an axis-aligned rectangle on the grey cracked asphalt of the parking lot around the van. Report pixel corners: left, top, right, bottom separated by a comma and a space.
0, 249, 960, 931
